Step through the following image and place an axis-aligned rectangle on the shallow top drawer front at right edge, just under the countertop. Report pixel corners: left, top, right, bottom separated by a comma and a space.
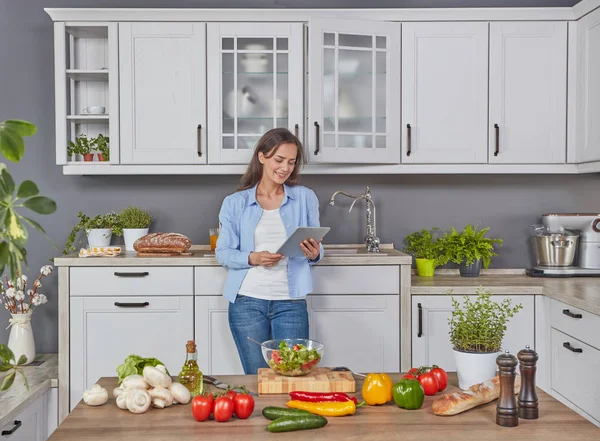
550, 299, 600, 349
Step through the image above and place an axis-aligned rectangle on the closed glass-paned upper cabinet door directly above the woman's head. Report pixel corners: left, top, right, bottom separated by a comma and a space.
207, 23, 304, 164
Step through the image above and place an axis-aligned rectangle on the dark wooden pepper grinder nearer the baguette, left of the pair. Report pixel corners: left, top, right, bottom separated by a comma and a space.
496, 350, 519, 427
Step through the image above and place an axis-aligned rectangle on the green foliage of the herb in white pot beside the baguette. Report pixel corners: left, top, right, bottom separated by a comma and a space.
448, 286, 523, 352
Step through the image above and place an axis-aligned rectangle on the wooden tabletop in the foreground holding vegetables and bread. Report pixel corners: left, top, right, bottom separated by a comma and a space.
50, 374, 600, 441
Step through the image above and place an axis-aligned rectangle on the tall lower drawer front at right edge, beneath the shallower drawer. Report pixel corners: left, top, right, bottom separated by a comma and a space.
551, 329, 600, 420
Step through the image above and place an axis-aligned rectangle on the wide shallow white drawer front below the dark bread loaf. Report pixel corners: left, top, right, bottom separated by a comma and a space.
69, 266, 194, 297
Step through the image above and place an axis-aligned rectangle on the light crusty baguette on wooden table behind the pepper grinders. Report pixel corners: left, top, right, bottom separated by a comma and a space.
431, 375, 521, 415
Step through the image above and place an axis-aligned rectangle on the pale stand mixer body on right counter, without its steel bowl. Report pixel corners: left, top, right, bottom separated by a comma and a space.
526, 213, 600, 277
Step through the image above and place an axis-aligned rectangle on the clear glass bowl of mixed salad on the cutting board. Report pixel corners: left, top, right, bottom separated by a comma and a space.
261, 338, 325, 377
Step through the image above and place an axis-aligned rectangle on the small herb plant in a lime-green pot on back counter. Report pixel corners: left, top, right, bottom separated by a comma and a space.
404, 227, 447, 277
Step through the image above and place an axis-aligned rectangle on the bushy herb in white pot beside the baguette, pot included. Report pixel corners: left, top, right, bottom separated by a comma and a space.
448, 286, 523, 390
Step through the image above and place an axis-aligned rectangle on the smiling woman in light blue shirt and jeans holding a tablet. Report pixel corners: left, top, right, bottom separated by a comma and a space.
216, 129, 323, 374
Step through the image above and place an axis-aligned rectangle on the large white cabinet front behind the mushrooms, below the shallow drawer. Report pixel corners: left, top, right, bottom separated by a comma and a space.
70, 296, 194, 409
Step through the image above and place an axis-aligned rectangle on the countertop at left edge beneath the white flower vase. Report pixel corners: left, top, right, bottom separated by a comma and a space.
0, 354, 58, 427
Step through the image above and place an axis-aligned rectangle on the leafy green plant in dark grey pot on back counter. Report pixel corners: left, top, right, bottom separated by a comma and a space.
443, 224, 503, 277
